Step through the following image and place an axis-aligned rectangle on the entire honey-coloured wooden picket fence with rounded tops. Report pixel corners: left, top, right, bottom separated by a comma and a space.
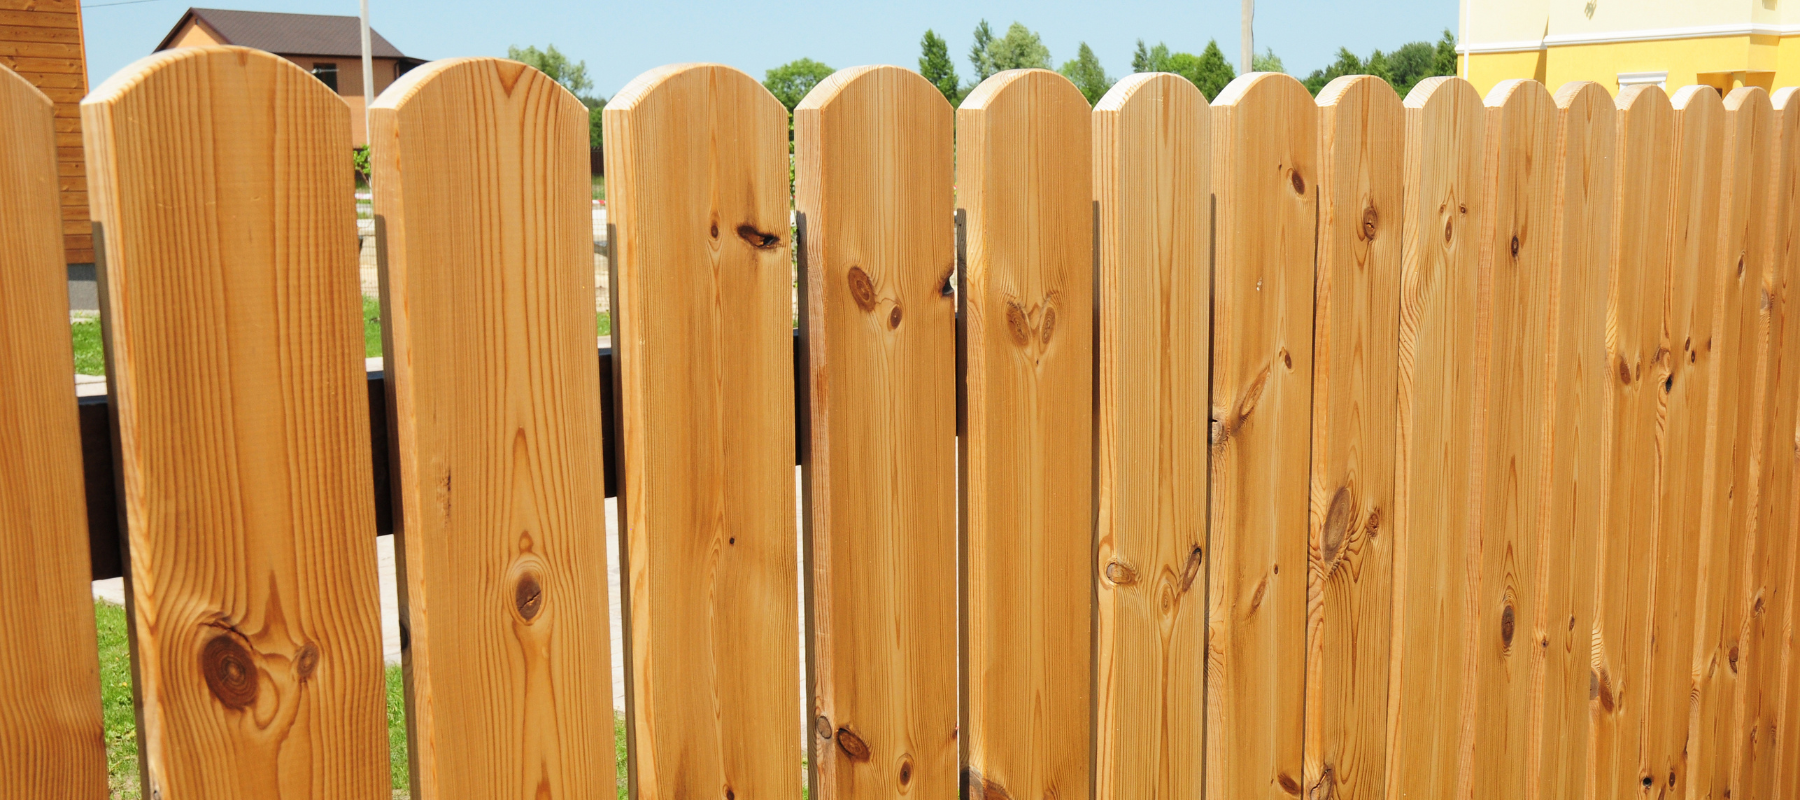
0, 47, 1800, 800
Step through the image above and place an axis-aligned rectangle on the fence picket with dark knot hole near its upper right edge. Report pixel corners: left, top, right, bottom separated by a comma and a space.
607, 65, 801, 798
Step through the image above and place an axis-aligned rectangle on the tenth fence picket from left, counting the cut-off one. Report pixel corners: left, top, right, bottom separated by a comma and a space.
1386, 77, 1489, 798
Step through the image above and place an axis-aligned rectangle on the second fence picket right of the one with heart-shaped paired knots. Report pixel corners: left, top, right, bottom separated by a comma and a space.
1206, 72, 1319, 800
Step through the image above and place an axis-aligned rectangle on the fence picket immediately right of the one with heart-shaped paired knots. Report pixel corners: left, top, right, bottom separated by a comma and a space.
1093, 72, 1211, 800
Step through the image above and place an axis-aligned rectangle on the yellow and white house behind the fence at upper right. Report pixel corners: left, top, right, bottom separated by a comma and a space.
1458, 0, 1800, 94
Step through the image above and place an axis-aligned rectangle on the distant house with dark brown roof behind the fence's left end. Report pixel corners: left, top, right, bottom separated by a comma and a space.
157, 9, 425, 144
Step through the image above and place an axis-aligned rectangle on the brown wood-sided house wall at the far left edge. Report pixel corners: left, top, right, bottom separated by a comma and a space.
0, 0, 94, 265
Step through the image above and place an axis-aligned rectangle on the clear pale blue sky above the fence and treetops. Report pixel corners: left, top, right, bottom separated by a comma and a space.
83, 0, 1456, 95
